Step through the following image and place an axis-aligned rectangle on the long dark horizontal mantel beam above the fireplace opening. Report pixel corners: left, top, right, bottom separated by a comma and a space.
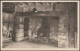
16, 11, 66, 17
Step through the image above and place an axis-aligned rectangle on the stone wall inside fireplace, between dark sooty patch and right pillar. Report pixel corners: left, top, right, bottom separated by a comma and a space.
49, 17, 59, 41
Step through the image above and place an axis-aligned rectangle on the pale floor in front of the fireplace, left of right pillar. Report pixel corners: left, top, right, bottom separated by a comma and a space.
3, 38, 58, 48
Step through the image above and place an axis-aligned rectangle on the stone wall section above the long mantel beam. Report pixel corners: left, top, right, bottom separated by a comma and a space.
15, 2, 53, 12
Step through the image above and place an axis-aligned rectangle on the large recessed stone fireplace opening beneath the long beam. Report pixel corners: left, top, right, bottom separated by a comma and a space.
19, 16, 59, 46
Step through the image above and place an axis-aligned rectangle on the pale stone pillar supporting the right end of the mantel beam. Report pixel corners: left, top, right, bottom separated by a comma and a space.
58, 15, 68, 47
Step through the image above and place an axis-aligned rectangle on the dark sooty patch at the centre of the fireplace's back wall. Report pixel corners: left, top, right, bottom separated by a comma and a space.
37, 17, 50, 37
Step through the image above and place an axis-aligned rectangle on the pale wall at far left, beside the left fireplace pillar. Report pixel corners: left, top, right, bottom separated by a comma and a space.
2, 13, 14, 36
